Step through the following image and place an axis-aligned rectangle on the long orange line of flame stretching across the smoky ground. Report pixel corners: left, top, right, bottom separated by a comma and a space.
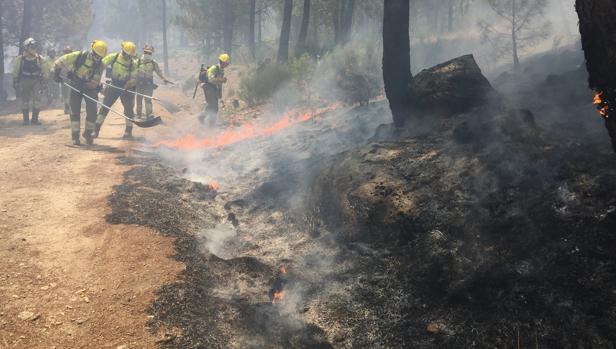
154, 103, 339, 150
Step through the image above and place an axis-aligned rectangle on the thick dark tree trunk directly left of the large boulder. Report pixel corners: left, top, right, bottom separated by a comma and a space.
383, 0, 413, 127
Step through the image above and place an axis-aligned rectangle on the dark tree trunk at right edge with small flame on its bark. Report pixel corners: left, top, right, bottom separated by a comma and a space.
575, 0, 616, 151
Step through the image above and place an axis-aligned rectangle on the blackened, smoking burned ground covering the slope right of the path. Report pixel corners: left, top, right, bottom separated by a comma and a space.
103, 53, 616, 348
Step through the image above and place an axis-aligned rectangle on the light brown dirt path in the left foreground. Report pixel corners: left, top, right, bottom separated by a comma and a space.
0, 110, 183, 348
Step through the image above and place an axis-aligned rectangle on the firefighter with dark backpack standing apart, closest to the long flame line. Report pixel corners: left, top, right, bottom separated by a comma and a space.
199, 53, 231, 127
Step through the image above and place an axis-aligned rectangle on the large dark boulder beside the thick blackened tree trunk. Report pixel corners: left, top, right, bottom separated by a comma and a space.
411, 55, 496, 116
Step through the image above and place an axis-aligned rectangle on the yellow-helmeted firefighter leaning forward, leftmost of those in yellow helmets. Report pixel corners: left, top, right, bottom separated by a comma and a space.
54, 40, 107, 145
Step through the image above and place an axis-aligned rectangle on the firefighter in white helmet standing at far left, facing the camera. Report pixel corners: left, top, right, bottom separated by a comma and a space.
13, 38, 49, 126
